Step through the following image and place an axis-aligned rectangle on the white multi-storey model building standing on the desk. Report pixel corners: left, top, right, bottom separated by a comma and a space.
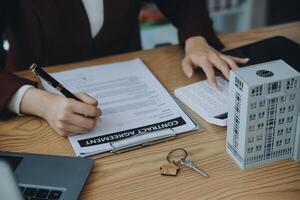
226, 60, 300, 169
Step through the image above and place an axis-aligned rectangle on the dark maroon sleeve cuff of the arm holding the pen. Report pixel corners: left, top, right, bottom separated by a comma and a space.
0, 70, 36, 119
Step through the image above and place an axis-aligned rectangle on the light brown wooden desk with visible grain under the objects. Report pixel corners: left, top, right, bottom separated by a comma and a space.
0, 22, 300, 200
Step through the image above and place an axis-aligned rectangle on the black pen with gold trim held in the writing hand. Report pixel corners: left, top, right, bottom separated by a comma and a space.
29, 63, 100, 120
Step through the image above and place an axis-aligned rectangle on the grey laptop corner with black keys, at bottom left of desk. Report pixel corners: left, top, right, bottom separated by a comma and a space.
0, 151, 94, 200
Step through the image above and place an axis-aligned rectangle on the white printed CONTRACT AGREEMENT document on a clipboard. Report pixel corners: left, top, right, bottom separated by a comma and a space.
42, 59, 198, 157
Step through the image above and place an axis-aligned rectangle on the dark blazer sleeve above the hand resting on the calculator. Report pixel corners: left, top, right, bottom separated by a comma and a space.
152, 0, 224, 50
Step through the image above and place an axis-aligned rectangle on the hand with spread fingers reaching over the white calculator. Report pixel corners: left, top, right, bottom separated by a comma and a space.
182, 36, 249, 88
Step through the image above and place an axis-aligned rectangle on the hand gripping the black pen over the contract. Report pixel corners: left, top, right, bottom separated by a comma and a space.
20, 89, 101, 136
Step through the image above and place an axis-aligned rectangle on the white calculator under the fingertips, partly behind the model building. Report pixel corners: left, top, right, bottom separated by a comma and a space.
175, 76, 229, 126
